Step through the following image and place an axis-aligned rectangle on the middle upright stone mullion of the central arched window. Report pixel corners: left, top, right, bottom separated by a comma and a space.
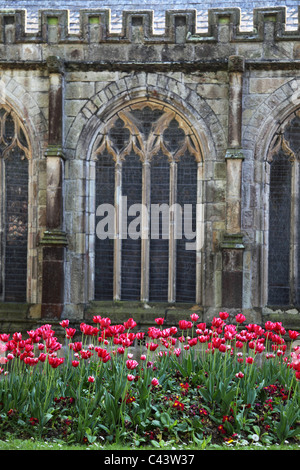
141, 159, 151, 302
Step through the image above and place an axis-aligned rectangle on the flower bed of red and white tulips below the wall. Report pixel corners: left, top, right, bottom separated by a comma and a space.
0, 312, 300, 446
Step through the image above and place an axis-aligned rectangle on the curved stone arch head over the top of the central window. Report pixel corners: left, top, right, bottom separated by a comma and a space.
65, 73, 227, 159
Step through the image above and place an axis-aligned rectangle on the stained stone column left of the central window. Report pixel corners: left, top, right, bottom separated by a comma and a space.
41, 57, 67, 318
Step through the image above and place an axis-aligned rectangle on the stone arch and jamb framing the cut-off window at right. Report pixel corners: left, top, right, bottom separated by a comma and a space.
242, 77, 300, 308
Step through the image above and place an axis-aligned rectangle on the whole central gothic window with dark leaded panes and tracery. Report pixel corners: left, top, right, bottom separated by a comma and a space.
93, 101, 202, 302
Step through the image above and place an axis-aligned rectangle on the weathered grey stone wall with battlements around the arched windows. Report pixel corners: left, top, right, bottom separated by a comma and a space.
0, 5, 300, 334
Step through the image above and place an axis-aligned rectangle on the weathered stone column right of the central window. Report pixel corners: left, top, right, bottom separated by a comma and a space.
222, 56, 244, 308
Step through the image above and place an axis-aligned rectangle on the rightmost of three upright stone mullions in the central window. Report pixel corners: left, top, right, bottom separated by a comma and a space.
168, 161, 178, 303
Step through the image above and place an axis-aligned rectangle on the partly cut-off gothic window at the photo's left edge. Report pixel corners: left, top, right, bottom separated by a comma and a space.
0, 107, 29, 302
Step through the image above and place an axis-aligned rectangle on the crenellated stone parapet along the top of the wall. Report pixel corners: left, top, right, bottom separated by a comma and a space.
0, 7, 300, 44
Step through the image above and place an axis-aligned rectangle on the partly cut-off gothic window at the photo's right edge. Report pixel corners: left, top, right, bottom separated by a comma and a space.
268, 113, 300, 306
